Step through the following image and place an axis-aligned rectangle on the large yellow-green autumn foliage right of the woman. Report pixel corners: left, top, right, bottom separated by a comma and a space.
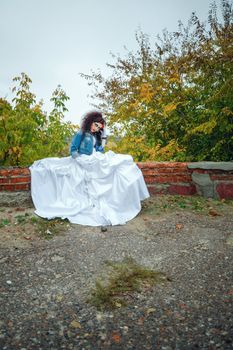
81, 0, 233, 161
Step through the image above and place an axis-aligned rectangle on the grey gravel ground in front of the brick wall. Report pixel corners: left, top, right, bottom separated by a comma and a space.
0, 196, 233, 350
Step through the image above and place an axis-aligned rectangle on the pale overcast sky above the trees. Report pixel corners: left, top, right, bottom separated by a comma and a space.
0, 0, 215, 124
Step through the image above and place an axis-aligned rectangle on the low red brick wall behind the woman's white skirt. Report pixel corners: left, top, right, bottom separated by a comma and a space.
0, 162, 233, 199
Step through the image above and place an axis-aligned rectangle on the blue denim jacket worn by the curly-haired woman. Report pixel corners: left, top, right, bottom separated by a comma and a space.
70, 131, 104, 158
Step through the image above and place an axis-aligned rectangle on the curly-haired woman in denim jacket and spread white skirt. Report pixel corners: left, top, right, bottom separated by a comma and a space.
30, 111, 149, 226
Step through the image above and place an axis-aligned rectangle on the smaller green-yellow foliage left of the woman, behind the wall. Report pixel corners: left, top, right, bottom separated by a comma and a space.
0, 73, 74, 165
